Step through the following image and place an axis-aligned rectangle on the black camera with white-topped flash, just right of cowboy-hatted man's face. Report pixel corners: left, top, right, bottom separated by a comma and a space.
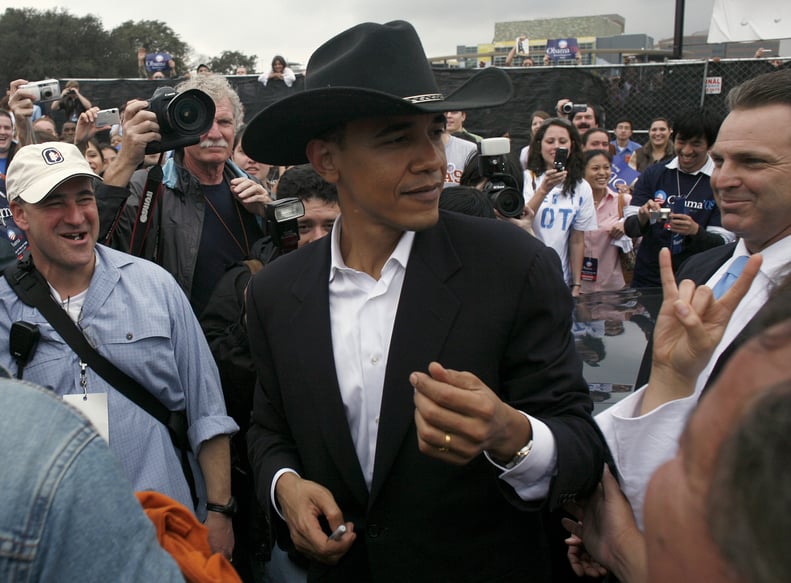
478, 138, 525, 217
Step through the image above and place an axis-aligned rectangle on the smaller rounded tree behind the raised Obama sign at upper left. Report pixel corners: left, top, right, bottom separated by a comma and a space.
110, 20, 190, 77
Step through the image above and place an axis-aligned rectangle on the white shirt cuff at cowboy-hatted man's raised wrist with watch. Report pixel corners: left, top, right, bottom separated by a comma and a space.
484, 411, 558, 502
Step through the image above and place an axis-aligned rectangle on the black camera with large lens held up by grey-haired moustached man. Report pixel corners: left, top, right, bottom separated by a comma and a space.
146, 87, 215, 154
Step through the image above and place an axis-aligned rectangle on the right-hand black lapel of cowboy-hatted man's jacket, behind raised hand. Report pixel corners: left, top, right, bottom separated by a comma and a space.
370, 221, 461, 503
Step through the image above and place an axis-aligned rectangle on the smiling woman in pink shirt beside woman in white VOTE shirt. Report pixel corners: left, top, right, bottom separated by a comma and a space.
582, 150, 632, 293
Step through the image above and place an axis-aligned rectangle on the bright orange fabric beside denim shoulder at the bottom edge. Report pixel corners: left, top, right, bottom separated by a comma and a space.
135, 491, 242, 583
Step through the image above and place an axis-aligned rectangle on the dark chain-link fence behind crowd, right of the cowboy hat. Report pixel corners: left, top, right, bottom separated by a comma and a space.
435, 58, 791, 146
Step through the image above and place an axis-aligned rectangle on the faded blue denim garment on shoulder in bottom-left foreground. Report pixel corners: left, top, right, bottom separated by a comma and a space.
0, 371, 184, 583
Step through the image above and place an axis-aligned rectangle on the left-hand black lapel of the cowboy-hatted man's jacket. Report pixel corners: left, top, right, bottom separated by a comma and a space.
284, 236, 368, 507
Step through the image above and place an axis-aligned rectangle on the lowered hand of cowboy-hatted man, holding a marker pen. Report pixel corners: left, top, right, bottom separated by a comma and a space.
275, 472, 357, 565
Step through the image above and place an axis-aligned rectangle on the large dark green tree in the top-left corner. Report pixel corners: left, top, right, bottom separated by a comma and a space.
0, 8, 115, 87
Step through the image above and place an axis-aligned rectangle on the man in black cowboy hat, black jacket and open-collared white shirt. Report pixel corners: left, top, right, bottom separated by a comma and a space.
243, 22, 605, 582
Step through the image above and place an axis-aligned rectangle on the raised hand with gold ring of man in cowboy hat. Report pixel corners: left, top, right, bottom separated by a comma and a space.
409, 362, 532, 465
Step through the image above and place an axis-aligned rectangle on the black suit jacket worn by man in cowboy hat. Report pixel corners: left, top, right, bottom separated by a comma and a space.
247, 212, 606, 583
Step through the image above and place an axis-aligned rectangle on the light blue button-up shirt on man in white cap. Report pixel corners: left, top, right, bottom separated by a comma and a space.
0, 245, 238, 518
